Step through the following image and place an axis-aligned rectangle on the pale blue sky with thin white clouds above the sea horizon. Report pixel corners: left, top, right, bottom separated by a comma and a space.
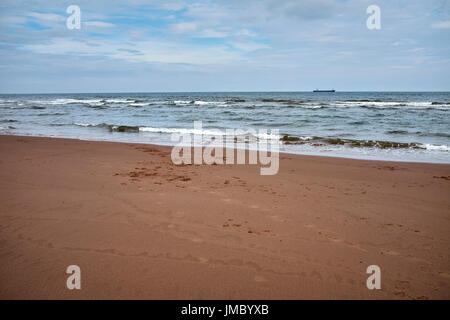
0, 0, 450, 93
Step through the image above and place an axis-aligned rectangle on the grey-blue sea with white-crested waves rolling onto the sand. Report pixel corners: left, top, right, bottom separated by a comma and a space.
0, 92, 450, 163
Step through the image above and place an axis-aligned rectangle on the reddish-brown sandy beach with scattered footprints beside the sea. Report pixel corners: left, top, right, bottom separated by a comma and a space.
0, 136, 450, 299
